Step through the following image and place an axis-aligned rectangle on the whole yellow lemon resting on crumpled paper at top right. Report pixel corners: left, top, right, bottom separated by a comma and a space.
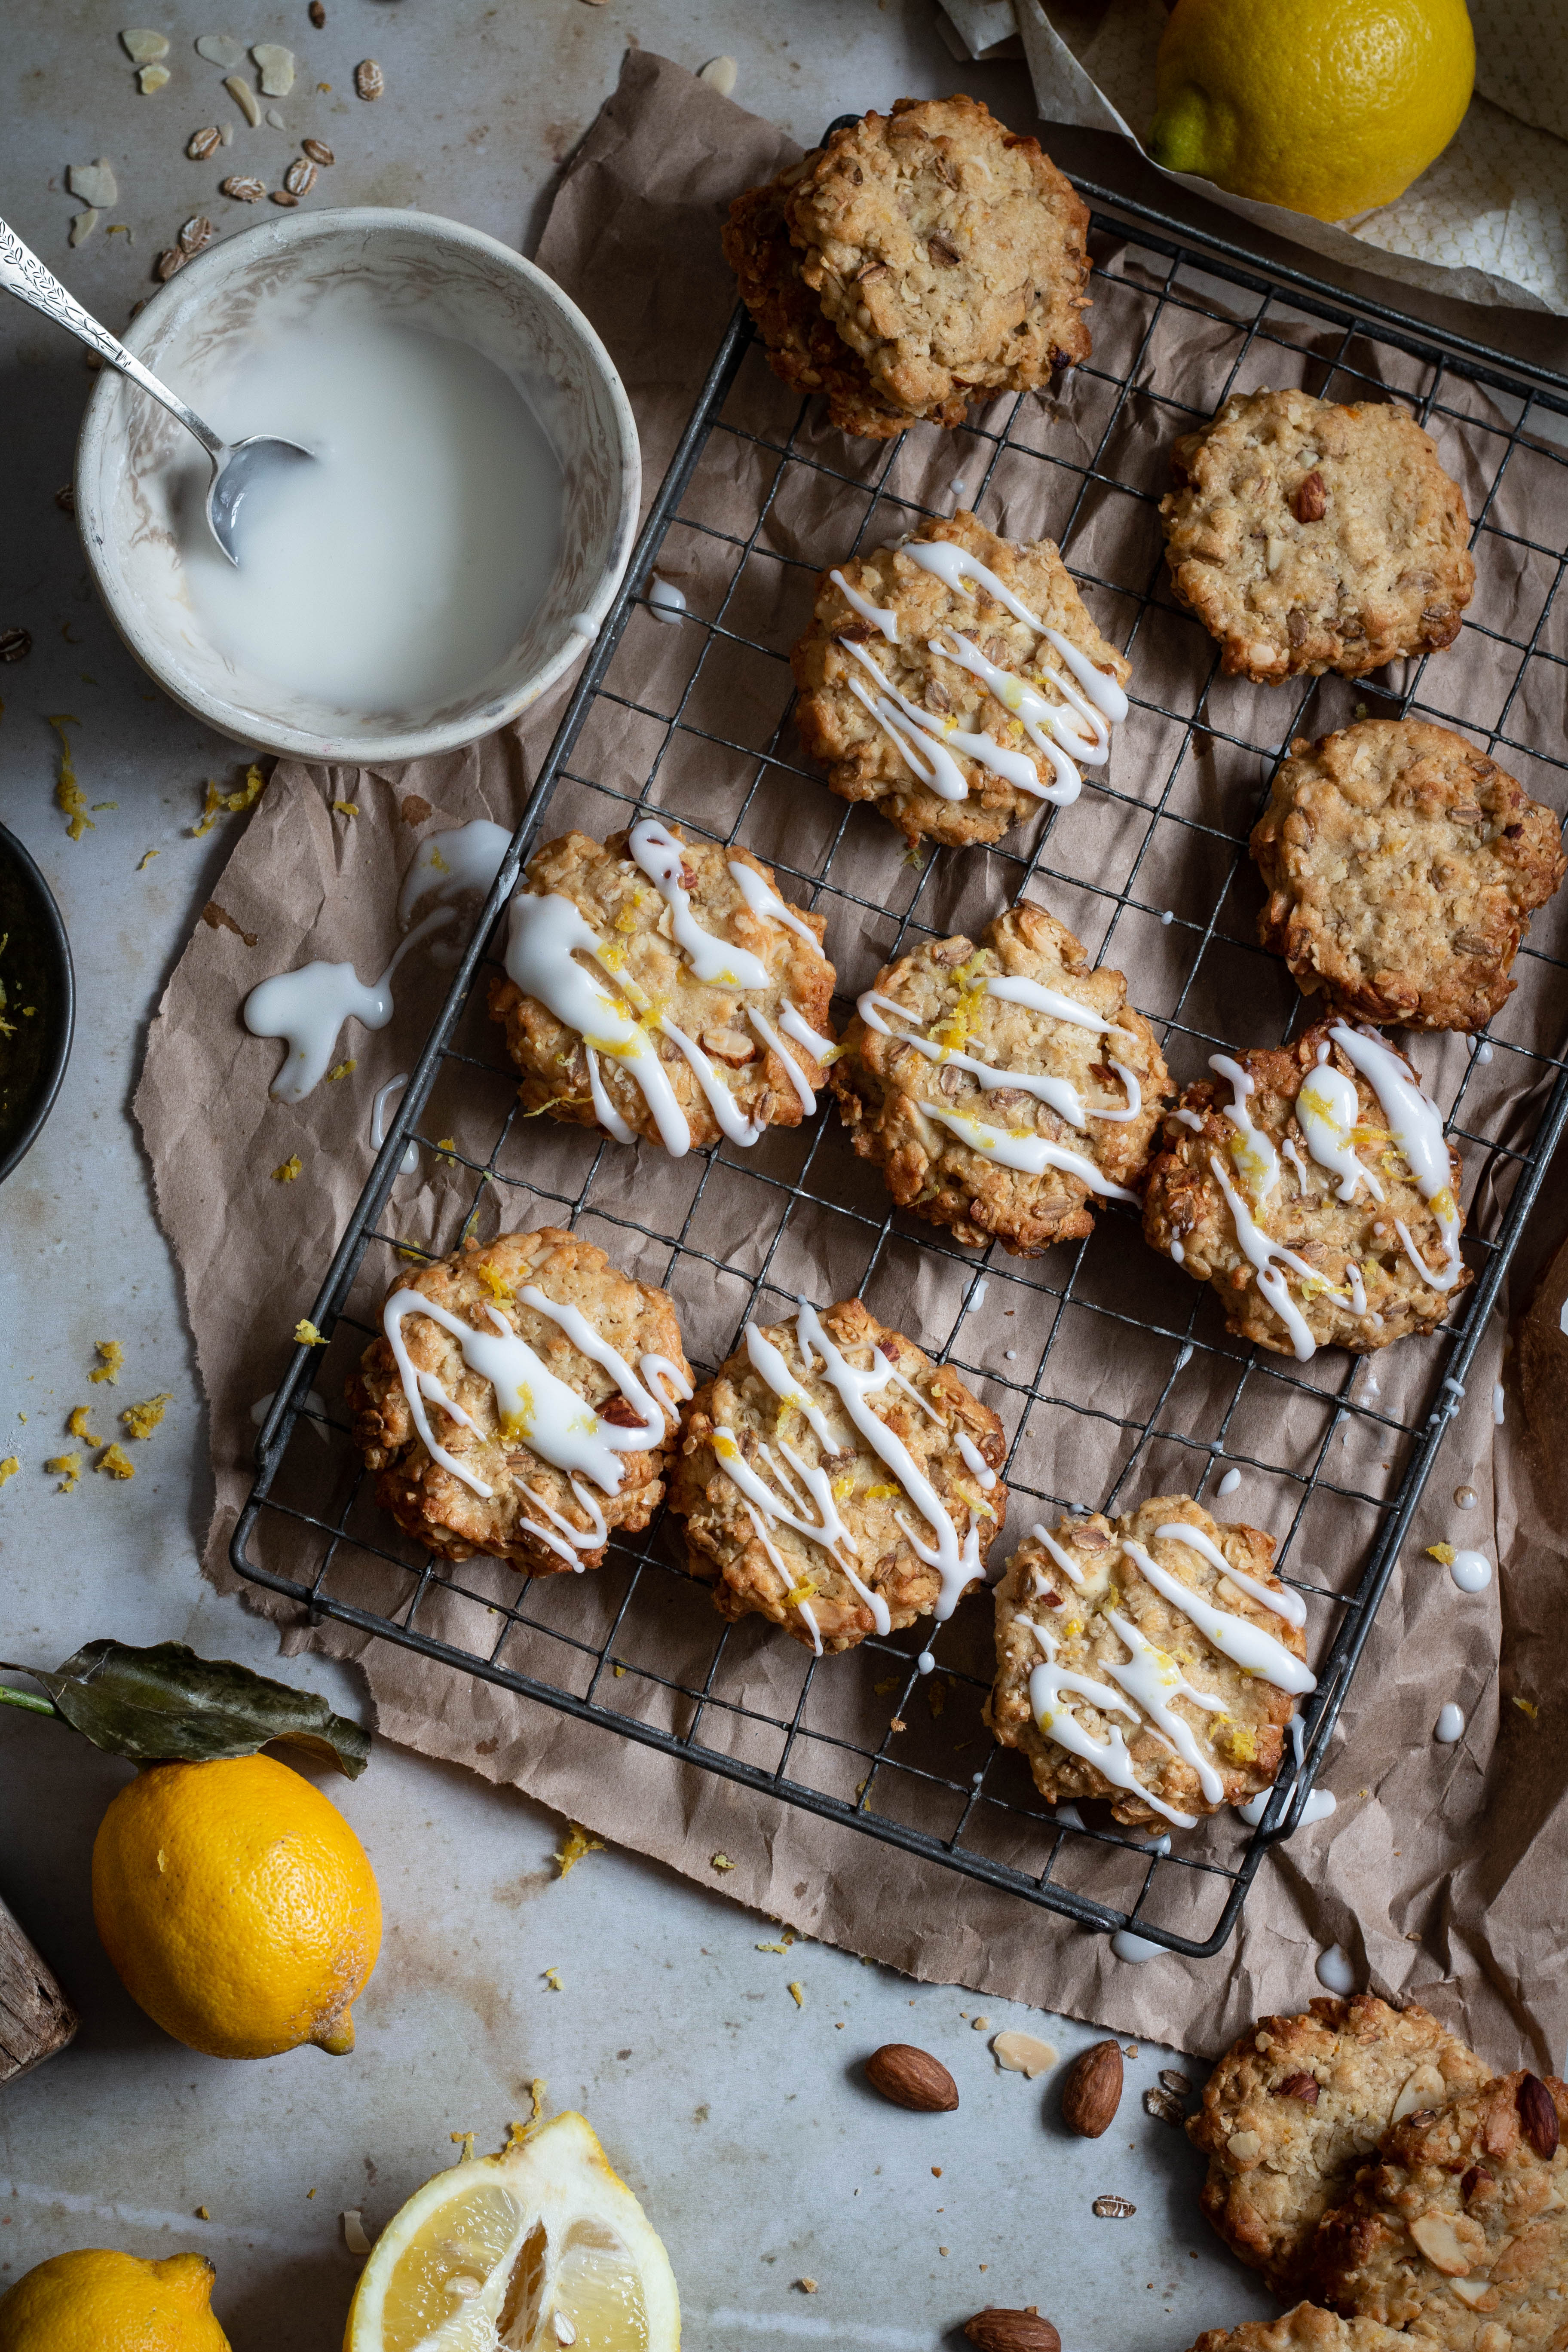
1147, 0, 1476, 221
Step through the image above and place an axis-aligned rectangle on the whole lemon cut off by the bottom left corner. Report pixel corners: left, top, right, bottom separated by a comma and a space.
0, 2246, 228, 2352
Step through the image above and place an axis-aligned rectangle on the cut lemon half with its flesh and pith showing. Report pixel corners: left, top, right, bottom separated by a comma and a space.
343, 2114, 680, 2352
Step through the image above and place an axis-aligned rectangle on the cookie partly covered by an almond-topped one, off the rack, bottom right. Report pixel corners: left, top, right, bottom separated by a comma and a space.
1187, 1992, 1491, 2298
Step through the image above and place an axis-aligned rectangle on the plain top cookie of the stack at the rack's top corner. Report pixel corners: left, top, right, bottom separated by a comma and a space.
783, 96, 1088, 416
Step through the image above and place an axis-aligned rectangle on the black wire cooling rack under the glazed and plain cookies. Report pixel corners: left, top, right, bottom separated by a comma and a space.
233, 188, 1568, 1957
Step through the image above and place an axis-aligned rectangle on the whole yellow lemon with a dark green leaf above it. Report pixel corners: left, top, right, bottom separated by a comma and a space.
92, 1757, 381, 2058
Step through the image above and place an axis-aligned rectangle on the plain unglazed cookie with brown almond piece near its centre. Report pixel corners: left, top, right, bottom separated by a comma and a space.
1159, 390, 1476, 682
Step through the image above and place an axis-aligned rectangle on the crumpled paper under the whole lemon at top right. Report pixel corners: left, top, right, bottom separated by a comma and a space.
938, 0, 1568, 315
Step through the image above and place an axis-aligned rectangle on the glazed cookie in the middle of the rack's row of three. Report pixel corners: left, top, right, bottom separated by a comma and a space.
830, 906, 1171, 1256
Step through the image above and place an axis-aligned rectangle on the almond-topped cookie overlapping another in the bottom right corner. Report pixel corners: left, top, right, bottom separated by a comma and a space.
1312, 2072, 1568, 2352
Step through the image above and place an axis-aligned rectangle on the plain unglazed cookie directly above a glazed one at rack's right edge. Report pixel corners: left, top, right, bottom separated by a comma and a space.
1253, 720, 1568, 1030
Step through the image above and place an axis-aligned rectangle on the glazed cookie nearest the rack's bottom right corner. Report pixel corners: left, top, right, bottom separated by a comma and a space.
985, 1494, 1314, 1830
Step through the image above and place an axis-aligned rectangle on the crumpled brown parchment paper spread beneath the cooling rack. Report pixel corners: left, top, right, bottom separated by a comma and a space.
136, 54, 1568, 2067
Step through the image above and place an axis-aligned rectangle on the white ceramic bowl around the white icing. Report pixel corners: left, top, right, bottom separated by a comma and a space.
75, 207, 642, 764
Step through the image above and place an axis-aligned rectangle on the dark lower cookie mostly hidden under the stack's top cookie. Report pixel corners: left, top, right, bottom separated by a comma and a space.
722, 170, 971, 440
